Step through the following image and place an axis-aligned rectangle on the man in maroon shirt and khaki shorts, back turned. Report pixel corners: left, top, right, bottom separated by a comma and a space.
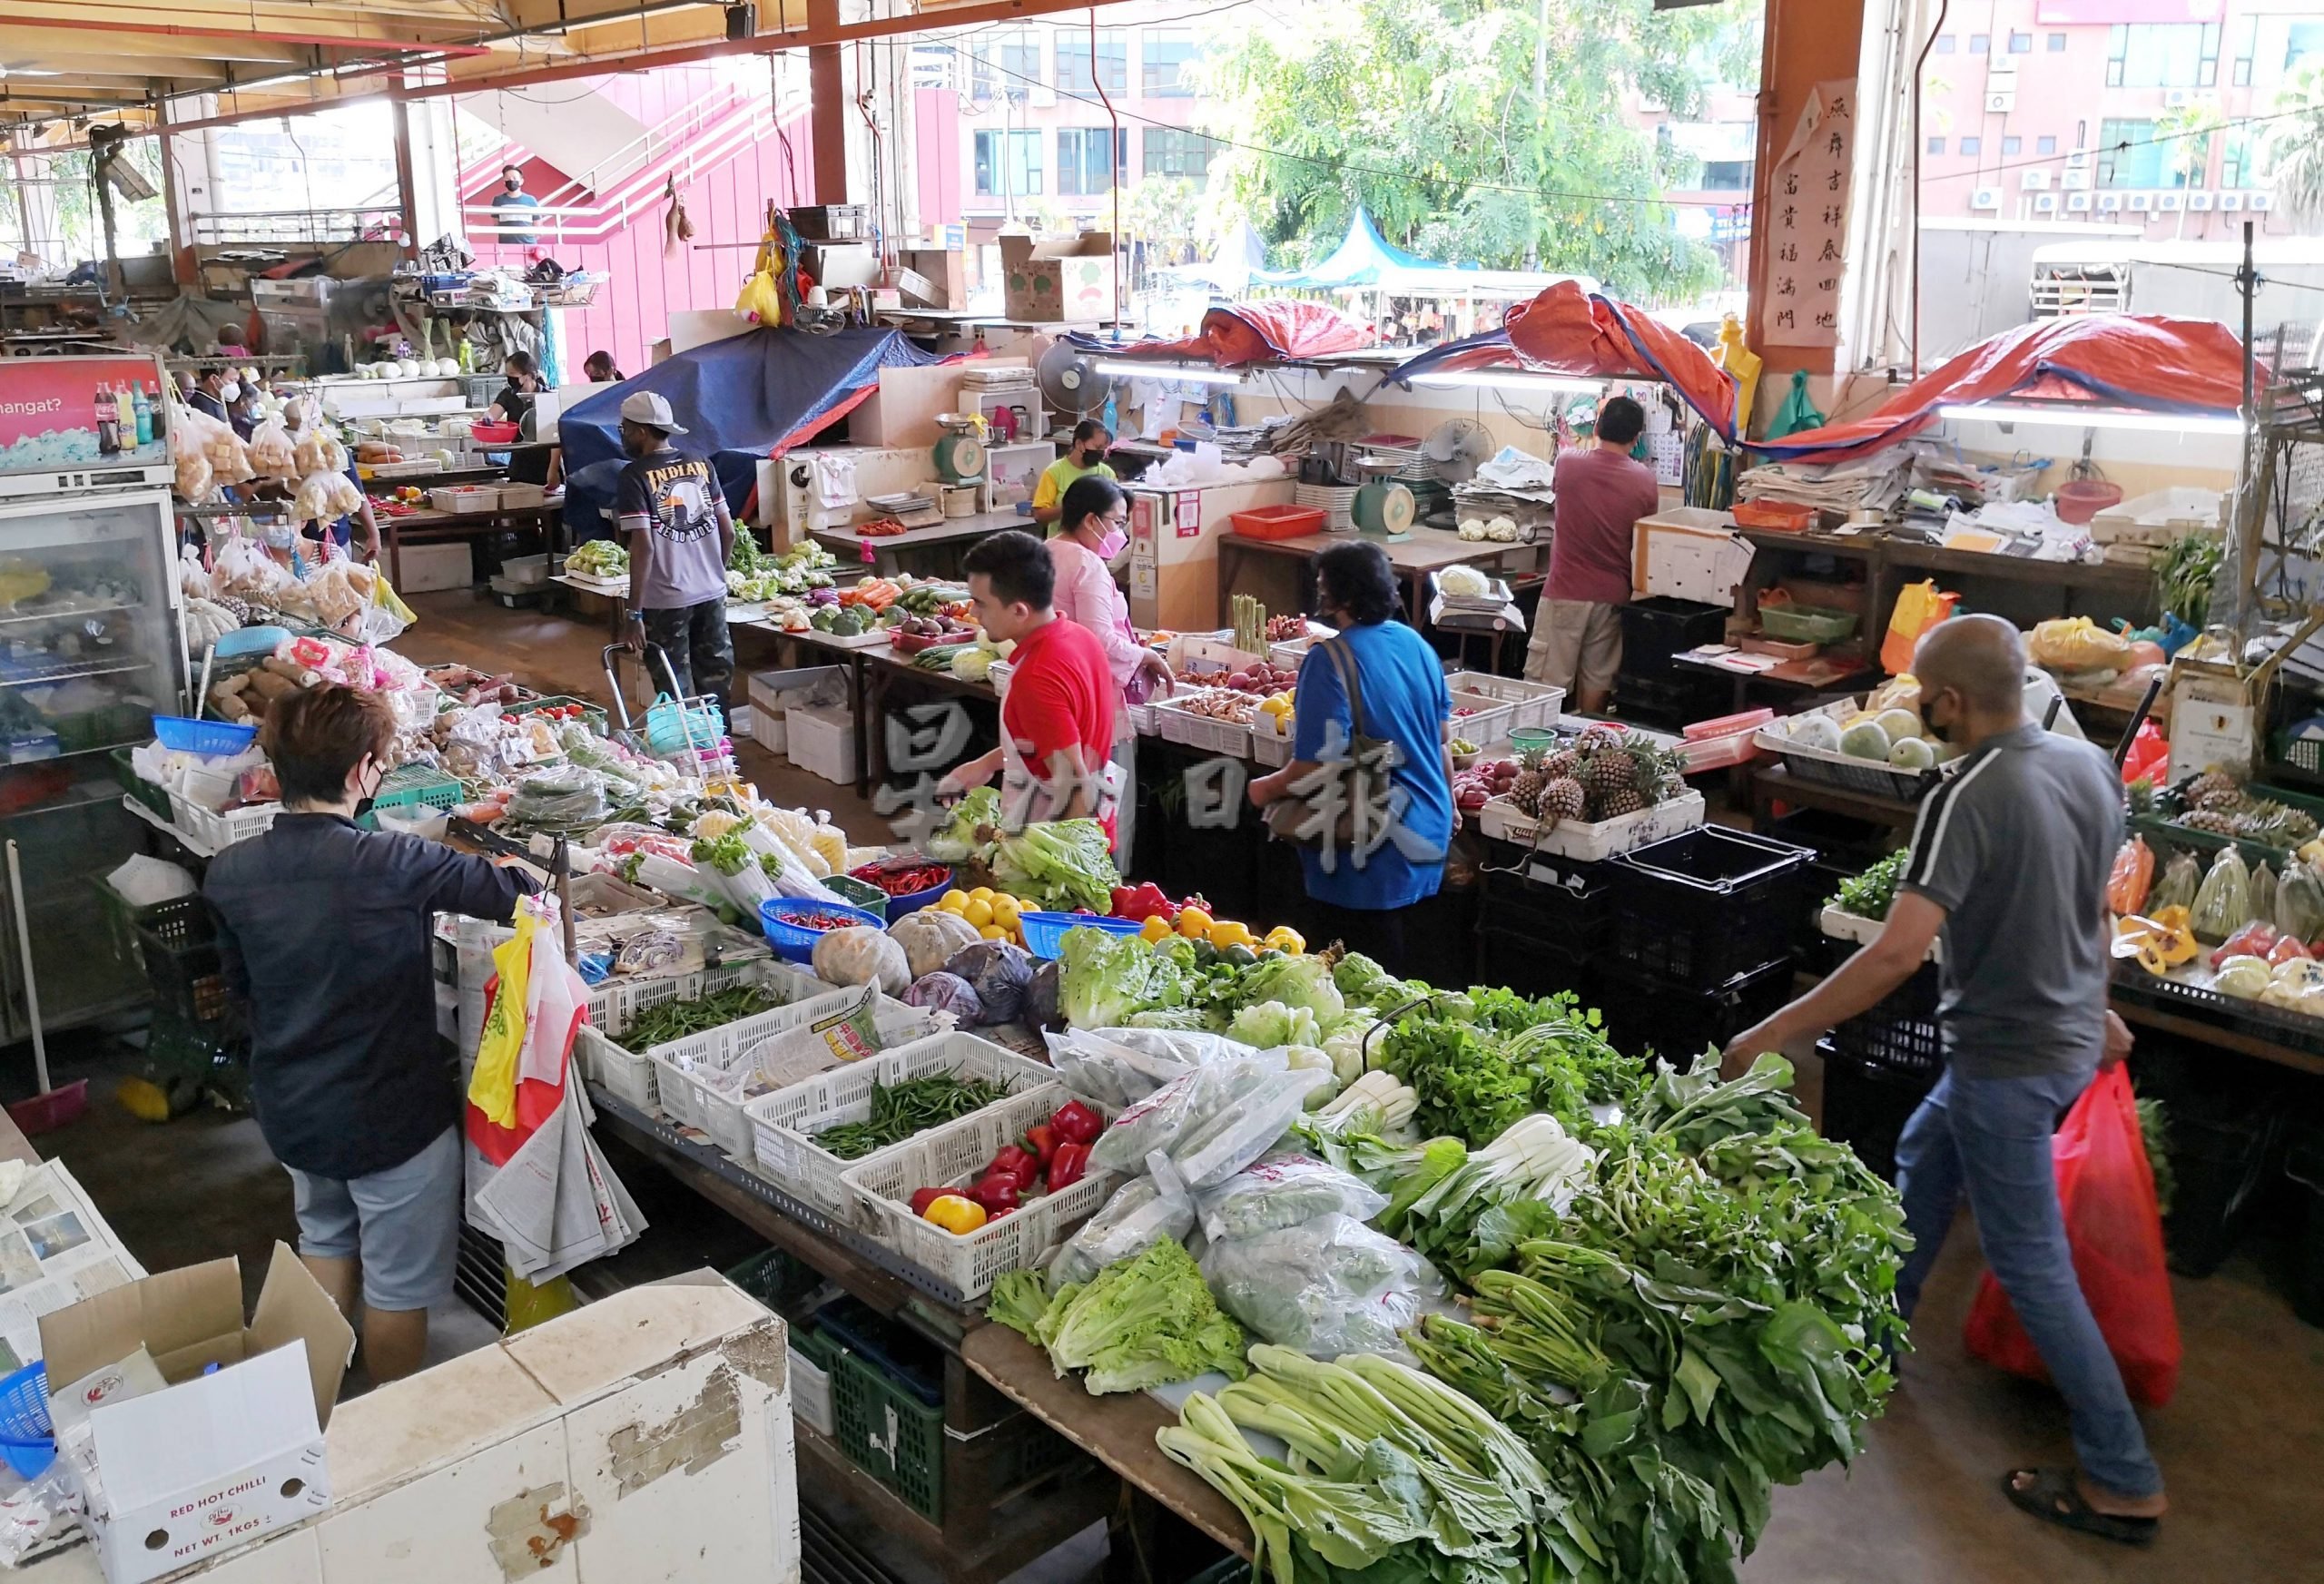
1524, 398, 1661, 715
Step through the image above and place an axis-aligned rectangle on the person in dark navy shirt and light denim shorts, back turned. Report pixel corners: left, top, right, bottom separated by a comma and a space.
202, 683, 532, 1382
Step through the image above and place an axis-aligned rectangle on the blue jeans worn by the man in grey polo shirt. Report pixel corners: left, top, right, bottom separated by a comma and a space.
1896, 1068, 2163, 1496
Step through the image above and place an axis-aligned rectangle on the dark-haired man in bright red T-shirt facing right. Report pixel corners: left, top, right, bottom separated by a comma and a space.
937, 529, 1120, 829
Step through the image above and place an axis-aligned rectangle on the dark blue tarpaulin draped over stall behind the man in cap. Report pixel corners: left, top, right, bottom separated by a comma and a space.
560, 328, 946, 539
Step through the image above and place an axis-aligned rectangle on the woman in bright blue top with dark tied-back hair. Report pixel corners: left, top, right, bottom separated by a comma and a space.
1248, 541, 1452, 961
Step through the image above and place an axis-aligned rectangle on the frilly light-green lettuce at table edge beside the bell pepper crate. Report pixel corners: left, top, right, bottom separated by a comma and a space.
985, 1238, 1250, 1396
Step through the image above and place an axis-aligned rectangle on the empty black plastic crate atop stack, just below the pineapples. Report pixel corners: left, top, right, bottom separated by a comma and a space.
1609, 824, 1815, 989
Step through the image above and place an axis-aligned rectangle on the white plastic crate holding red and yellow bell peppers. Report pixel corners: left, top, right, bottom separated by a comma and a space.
842, 1085, 1118, 1301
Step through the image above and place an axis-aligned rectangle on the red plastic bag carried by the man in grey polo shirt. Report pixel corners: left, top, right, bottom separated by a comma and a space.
1962, 1064, 2180, 1408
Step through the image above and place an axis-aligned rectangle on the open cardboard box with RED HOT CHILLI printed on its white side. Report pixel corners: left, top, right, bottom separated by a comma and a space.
40, 1243, 356, 1584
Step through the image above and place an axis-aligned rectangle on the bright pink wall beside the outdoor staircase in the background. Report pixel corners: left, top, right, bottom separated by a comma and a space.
458, 67, 813, 379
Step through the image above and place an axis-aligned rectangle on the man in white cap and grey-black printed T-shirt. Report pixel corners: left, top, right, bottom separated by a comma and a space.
614, 390, 734, 711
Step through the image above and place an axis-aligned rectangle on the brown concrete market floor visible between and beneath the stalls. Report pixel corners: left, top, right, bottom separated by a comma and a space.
27, 595, 2324, 1584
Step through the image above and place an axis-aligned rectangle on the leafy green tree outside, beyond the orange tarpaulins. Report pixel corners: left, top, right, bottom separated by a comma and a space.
1202, 0, 1759, 300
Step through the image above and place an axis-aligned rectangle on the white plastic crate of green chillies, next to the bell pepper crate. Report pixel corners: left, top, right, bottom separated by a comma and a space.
743, 1028, 1058, 1222
